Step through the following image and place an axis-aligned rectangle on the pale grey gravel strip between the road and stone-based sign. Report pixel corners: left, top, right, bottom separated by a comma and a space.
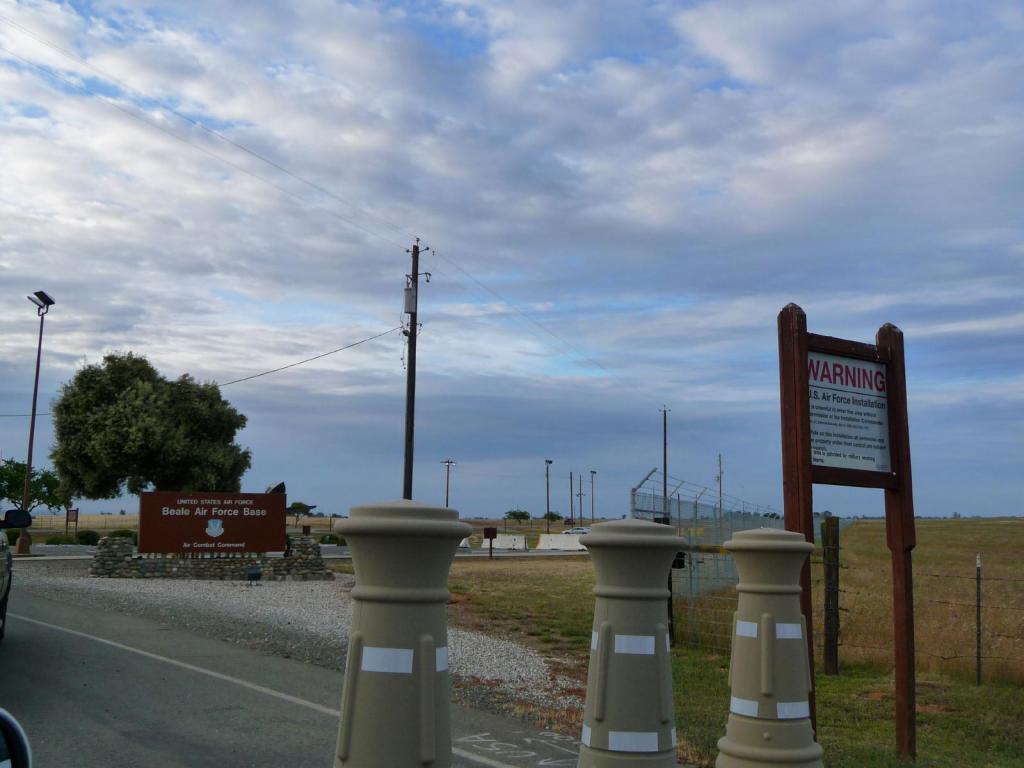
14, 560, 582, 713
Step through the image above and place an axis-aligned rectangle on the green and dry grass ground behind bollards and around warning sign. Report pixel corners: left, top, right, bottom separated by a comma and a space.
425, 520, 1024, 768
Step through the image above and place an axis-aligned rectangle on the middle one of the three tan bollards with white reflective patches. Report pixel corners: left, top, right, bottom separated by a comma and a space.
579, 519, 686, 768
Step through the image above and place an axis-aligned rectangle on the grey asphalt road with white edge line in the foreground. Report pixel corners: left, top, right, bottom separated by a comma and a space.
0, 587, 578, 768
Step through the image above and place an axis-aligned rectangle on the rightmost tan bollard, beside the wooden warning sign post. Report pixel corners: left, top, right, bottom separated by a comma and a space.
715, 528, 822, 768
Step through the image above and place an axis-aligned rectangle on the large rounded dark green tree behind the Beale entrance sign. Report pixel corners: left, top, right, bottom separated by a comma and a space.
51, 352, 251, 499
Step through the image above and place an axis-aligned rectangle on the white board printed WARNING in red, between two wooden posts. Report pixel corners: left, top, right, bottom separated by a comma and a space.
807, 352, 892, 472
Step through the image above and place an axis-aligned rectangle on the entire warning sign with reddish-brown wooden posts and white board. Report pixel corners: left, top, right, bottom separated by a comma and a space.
778, 304, 918, 757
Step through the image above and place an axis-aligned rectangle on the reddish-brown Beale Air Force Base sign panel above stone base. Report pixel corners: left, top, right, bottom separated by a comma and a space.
138, 490, 286, 554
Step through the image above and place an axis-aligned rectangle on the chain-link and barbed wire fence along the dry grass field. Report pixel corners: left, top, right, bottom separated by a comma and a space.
633, 488, 1024, 684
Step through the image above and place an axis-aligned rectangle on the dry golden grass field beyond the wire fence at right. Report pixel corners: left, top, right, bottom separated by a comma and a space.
813, 518, 1024, 682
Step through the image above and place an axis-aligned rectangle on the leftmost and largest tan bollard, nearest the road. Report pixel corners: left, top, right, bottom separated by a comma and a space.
334, 501, 472, 768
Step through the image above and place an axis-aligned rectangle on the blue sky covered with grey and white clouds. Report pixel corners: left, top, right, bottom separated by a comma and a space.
0, 0, 1024, 516
